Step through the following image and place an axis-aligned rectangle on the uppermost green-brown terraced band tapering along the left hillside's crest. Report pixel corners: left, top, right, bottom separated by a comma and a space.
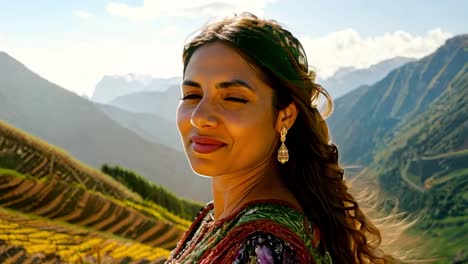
0, 120, 139, 199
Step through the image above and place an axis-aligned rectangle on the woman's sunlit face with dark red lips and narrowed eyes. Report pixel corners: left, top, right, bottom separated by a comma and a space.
177, 42, 278, 176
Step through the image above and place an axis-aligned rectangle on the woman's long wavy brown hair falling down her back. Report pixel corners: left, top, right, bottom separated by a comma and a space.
183, 13, 412, 263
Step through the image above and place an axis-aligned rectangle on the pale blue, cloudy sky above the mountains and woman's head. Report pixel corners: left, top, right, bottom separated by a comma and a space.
0, 0, 468, 96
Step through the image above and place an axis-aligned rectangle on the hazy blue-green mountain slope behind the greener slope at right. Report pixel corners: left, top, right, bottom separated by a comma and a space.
327, 35, 468, 164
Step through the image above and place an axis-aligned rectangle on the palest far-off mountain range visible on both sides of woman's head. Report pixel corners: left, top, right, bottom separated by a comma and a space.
91, 57, 413, 146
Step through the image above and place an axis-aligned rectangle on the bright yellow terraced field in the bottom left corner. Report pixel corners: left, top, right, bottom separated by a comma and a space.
0, 209, 169, 263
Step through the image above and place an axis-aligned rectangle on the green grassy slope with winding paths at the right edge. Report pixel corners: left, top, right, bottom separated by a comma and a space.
372, 63, 468, 263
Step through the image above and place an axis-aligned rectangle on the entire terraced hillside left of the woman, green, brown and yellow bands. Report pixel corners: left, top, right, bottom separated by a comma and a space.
0, 121, 197, 263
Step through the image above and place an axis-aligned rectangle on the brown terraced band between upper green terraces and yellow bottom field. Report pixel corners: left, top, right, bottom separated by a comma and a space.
0, 170, 184, 249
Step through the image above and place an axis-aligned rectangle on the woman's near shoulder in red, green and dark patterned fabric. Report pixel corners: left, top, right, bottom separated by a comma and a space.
212, 200, 331, 263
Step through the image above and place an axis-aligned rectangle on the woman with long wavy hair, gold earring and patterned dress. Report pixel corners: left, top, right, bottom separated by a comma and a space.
167, 13, 402, 264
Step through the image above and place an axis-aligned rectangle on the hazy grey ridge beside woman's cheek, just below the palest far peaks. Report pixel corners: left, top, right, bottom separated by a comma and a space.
109, 84, 181, 121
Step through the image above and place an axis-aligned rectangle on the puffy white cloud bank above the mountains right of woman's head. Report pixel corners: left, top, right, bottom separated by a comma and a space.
300, 28, 453, 78
